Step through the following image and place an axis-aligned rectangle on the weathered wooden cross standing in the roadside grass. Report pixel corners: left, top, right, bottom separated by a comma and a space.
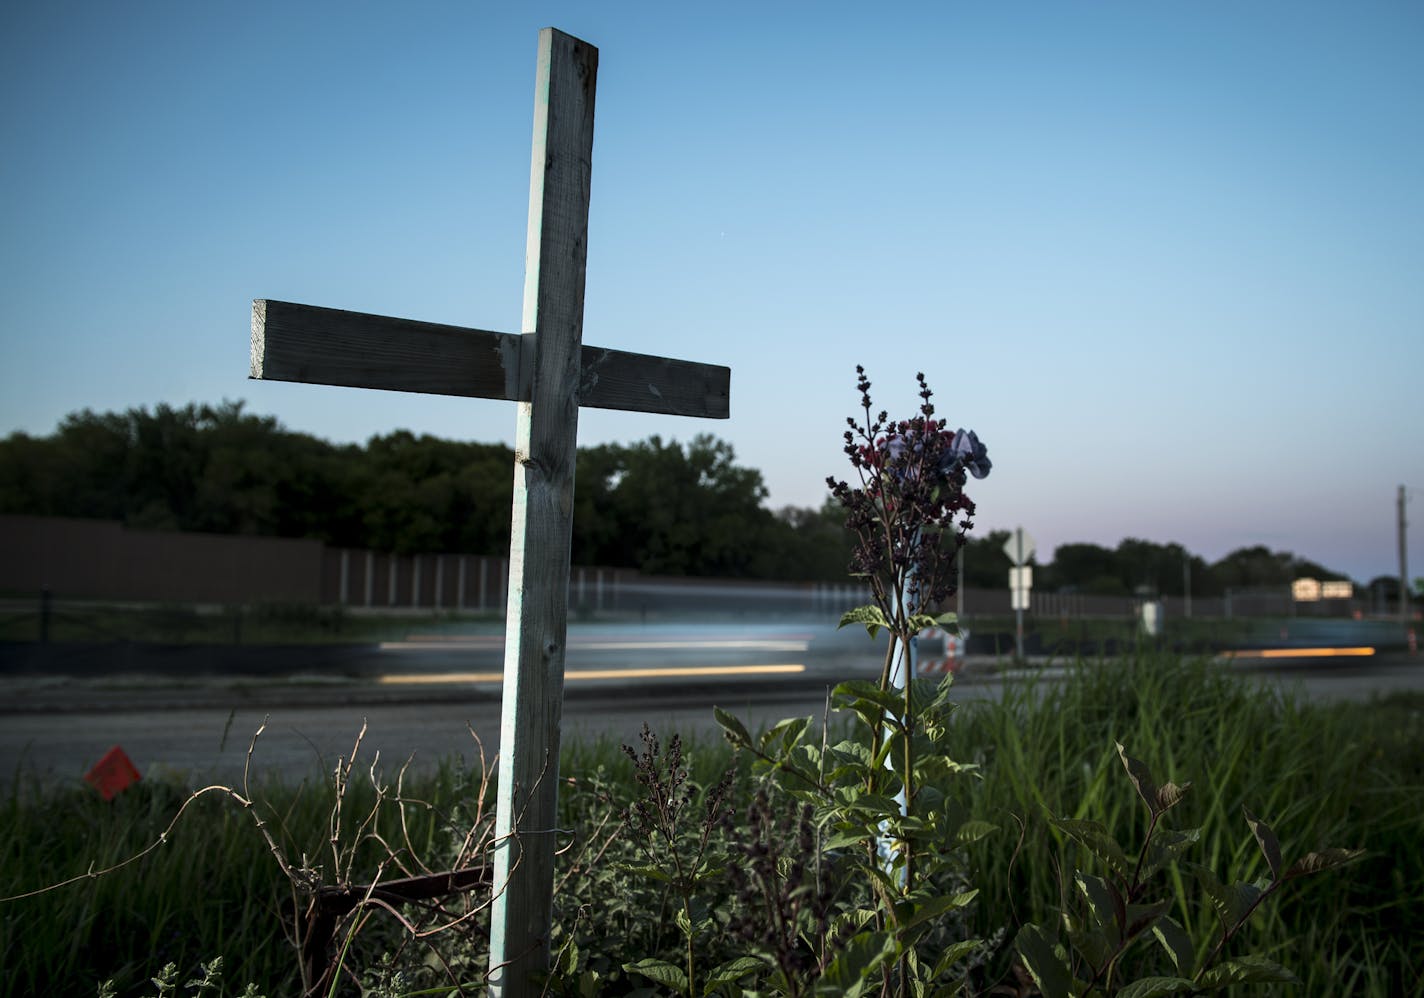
252, 28, 731, 995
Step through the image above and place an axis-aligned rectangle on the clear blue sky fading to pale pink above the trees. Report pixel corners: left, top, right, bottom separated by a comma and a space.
0, 0, 1424, 582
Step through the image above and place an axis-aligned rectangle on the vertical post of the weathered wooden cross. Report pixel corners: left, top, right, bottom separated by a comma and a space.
490, 28, 598, 997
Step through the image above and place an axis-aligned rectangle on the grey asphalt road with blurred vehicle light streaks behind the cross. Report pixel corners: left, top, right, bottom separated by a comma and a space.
0, 624, 1424, 786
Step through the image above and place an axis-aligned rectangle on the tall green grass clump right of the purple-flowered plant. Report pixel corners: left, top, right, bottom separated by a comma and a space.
954, 655, 1424, 995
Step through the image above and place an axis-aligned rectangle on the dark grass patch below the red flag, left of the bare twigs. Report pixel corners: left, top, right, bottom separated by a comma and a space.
0, 780, 297, 995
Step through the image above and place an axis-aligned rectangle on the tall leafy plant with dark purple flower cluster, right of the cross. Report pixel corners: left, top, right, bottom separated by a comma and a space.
716, 367, 991, 995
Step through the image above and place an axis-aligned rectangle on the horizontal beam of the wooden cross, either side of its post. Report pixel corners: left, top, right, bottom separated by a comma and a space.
251, 298, 732, 419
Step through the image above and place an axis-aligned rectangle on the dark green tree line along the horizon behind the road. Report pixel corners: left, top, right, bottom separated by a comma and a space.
0, 401, 1340, 595
